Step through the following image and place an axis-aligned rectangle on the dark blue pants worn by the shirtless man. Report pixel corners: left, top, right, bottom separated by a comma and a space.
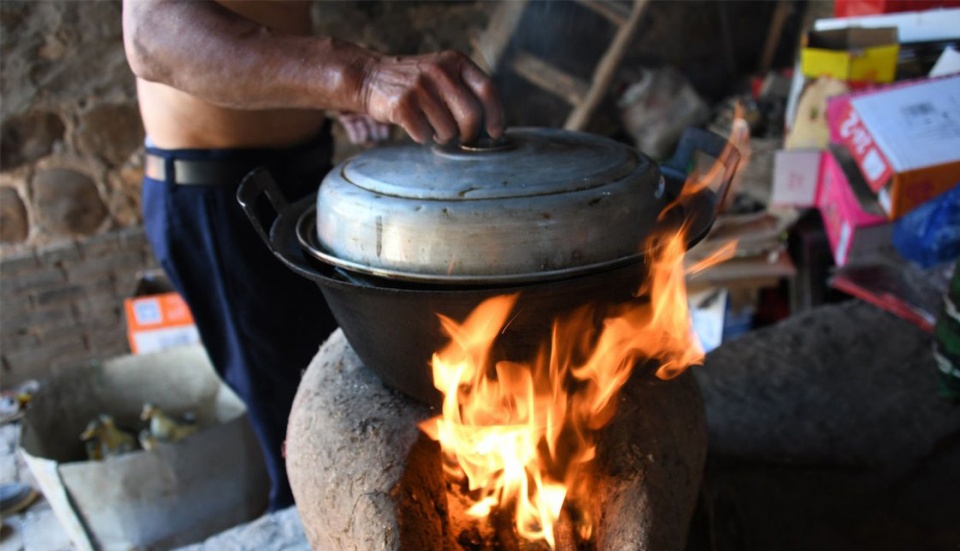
143, 126, 336, 511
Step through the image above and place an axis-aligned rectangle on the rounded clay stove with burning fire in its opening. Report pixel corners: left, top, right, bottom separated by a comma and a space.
286, 331, 706, 551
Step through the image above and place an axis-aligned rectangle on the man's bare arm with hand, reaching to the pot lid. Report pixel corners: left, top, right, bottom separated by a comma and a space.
123, 0, 503, 142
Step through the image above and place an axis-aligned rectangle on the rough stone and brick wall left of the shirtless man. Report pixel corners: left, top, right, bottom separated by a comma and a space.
0, 0, 148, 388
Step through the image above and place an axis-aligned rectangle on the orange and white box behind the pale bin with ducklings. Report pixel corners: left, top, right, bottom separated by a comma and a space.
124, 270, 200, 354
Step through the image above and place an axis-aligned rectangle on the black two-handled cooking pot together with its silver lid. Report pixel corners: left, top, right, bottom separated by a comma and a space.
238, 128, 738, 404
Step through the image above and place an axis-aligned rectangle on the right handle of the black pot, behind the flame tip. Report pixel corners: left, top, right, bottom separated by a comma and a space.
660, 127, 740, 211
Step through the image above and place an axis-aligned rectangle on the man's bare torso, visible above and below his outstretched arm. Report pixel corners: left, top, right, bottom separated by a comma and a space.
137, 0, 324, 149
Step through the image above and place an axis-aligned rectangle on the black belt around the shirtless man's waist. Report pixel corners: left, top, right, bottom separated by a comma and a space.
143, 138, 330, 186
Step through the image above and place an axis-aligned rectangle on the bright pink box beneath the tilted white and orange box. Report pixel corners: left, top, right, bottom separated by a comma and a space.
817, 151, 893, 266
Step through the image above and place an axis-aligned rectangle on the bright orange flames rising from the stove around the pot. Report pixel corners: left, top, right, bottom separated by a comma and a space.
421, 121, 735, 549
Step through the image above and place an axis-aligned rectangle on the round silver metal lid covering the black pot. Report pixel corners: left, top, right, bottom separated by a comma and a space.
311, 128, 668, 283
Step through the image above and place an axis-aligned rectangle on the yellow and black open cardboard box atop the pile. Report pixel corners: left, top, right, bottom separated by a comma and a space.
800, 27, 900, 83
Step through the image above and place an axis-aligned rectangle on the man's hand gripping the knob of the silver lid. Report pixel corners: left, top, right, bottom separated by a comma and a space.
360, 50, 503, 143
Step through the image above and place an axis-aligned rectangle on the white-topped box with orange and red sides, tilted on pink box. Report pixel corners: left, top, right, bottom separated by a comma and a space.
827, 74, 960, 219
